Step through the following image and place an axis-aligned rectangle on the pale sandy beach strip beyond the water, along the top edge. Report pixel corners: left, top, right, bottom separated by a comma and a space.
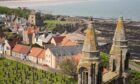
0, 0, 95, 7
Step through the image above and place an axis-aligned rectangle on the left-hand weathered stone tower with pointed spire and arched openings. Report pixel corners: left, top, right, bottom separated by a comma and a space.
78, 20, 102, 84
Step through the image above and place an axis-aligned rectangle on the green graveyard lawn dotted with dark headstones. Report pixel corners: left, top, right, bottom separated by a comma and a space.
0, 58, 76, 84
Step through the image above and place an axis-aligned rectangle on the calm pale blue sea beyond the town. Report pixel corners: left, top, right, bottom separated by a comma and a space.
1, 0, 140, 20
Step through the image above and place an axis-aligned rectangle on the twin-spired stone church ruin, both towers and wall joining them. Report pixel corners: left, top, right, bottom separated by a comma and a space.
78, 17, 130, 84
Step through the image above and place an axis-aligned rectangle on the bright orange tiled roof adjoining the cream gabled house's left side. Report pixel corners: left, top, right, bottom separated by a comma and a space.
29, 47, 45, 58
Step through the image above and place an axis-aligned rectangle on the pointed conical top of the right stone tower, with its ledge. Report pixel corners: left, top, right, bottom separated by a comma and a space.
110, 17, 127, 54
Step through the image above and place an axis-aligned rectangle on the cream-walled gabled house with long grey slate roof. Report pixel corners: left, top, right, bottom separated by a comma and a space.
46, 46, 82, 68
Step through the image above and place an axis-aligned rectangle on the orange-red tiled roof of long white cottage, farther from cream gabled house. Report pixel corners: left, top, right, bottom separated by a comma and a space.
12, 44, 30, 54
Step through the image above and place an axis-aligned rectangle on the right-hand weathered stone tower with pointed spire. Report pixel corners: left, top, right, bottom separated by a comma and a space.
109, 17, 130, 84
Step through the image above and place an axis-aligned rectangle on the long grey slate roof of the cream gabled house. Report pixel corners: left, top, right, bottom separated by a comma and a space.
49, 45, 82, 56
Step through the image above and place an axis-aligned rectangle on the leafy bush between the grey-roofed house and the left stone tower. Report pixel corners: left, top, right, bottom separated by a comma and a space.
59, 58, 78, 79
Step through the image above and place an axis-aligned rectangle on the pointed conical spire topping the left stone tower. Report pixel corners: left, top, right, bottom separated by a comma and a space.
82, 19, 98, 52
